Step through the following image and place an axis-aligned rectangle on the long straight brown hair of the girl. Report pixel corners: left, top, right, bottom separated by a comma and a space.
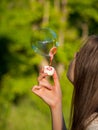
70, 35, 98, 130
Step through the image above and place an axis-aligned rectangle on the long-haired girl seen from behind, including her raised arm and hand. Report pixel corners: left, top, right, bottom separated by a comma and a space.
32, 35, 98, 130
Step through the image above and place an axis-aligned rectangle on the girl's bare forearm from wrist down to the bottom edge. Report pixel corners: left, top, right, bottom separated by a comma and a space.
51, 105, 67, 130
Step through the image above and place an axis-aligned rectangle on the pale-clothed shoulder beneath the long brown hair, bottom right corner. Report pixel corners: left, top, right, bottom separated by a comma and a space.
86, 113, 98, 130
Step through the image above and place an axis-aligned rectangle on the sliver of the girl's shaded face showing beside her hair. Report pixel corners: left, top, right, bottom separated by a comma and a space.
67, 53, 77, 84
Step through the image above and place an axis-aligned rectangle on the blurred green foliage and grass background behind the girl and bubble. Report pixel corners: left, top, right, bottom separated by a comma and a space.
0, 0, 98, 130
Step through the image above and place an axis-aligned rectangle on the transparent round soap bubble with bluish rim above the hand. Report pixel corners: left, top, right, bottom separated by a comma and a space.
31, 28, 59, 57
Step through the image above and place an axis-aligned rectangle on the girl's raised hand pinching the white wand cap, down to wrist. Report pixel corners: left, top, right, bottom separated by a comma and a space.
32, 70, 62, 109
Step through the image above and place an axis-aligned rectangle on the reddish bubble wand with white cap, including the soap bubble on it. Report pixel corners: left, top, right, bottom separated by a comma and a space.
31, 28, 59, 76
